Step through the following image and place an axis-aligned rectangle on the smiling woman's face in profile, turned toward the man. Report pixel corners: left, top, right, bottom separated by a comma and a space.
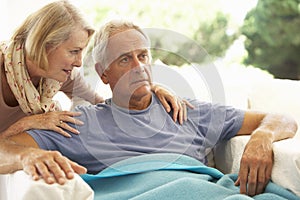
45, 29, 88, 82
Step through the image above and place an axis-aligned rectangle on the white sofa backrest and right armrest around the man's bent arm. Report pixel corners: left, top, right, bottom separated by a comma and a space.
153, 63, 300, 196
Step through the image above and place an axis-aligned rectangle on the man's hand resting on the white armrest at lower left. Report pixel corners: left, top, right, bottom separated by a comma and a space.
19, 148, 86, 184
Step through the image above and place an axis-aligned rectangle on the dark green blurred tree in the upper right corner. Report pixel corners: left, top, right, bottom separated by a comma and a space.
242, 0, 300, 79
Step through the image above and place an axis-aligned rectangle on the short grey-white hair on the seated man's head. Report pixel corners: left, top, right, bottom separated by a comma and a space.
93, 19, 150, 68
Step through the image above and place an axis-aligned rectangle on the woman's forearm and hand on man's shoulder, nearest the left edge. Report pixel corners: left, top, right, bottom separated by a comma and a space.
0, 111, 83, 138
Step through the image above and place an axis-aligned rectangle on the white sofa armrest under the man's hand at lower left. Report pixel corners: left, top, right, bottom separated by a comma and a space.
0, 171, 94, 200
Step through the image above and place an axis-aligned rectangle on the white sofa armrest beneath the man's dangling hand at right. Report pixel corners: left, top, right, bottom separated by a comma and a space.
214, 136, 300, 196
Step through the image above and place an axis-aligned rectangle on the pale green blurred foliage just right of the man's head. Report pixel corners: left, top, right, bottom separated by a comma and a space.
152, 12, 238, 66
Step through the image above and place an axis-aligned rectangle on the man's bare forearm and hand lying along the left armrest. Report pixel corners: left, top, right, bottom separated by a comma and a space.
0, 133, 86, 184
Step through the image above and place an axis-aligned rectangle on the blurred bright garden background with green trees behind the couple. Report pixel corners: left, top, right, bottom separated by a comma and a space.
0, 0, 300, 80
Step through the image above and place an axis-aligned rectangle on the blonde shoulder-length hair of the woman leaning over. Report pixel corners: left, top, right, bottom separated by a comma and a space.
12, 0, 95, 70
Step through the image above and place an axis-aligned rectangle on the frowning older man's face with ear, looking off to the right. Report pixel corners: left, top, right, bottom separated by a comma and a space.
101, 29, 151, 106
